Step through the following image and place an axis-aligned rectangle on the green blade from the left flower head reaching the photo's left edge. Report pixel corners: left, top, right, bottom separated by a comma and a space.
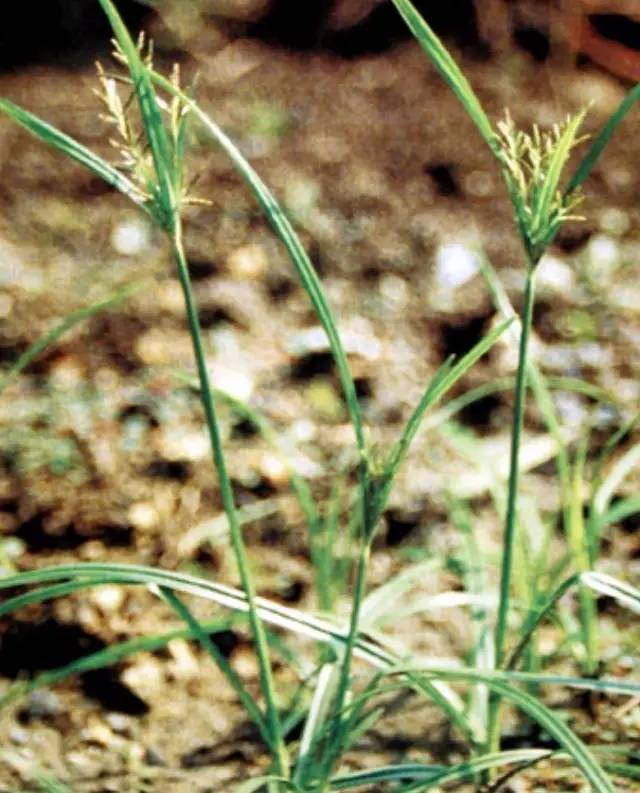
0, 99, 151, 214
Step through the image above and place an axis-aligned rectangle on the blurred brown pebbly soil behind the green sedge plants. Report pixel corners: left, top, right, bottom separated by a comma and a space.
0, 2, 640, 791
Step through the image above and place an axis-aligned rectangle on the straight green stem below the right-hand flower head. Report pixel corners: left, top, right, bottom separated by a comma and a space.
488, 262, 535, 751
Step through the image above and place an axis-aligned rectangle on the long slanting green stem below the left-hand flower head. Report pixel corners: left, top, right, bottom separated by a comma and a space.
170, 220, 289, 777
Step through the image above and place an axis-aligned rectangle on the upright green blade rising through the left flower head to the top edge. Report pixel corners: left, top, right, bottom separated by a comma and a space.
99, 0, 177, 223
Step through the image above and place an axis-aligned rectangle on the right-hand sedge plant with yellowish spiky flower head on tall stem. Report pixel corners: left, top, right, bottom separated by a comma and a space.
393, 0, 640, 772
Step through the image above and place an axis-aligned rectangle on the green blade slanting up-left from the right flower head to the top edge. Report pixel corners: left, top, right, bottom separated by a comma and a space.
393, 0, 497, 154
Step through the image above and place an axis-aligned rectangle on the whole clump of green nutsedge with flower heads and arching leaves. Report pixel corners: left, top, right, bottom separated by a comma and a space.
0, 0, 640, 793
